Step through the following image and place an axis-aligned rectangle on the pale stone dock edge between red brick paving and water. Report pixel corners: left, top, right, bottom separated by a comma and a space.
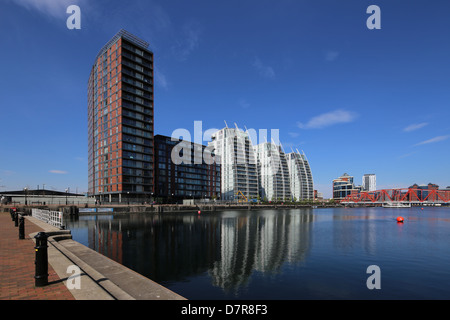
26, 216, 186, 300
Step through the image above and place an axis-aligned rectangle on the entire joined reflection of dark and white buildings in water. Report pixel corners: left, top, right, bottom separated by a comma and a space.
72, 209, 313, 291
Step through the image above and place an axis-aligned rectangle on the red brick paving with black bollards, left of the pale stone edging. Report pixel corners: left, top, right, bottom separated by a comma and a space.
0, 212, 75, 300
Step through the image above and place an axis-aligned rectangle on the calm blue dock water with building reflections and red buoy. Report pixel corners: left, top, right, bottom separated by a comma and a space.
66, 207, 450, 300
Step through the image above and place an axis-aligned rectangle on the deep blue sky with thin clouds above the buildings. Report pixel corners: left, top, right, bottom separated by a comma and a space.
0, 0, 450, 197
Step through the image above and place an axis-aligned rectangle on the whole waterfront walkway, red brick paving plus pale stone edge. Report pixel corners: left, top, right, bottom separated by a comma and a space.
0, 212, 185, 300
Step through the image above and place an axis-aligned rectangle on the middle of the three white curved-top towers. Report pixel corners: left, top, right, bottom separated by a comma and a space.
255, 142, 292, 201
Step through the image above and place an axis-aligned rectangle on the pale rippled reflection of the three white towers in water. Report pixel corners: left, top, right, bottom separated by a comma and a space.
210, 211, 313, 290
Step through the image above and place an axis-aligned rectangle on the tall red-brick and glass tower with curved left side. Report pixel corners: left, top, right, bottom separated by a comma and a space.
88, 30, 154, 202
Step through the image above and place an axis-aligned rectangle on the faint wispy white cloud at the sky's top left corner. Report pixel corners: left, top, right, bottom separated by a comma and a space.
12, 0, 84, 18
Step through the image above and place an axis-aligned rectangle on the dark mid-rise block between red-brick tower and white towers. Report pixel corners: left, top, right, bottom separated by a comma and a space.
153, 135, 220, 203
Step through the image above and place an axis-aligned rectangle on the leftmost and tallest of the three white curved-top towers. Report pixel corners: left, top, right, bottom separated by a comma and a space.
208, 127, 258, 202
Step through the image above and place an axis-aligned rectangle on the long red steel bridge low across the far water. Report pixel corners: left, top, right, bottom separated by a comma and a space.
340, 188, 450, 205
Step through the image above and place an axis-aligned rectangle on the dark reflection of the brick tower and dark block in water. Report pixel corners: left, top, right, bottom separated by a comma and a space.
88, 214, 220, 282
